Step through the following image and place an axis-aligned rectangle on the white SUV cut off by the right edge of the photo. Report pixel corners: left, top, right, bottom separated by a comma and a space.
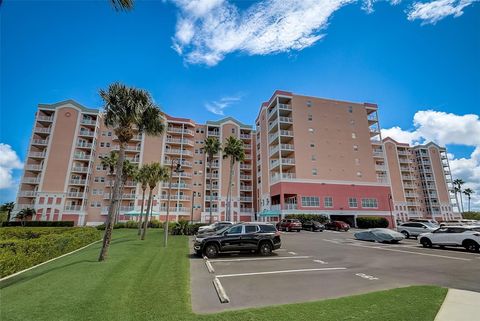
418, 225, 480, 252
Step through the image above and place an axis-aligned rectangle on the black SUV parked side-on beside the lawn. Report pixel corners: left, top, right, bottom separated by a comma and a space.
193, 222, 282, 258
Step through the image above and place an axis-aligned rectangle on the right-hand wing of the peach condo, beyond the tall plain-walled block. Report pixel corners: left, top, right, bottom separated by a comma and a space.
383, 137, 461, 221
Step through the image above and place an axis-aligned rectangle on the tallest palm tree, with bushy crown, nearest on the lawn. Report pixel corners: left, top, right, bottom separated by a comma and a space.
98, 83, 165, 261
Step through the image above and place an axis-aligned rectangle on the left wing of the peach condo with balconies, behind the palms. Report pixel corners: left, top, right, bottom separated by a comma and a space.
14, 100, 256, 225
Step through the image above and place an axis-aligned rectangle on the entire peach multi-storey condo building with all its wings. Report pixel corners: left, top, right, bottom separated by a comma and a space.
14, 91, 456, 226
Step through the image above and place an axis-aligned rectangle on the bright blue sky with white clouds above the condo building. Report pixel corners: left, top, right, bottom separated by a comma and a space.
0, 0, 480, 204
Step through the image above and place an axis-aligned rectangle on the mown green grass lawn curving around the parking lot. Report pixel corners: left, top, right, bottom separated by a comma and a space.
0, 230, 447, 321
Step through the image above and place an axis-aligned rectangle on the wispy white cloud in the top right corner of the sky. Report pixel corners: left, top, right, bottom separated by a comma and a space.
407, 0, 477, 24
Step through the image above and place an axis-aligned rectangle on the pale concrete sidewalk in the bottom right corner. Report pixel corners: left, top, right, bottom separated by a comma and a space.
435, 289, 480, 321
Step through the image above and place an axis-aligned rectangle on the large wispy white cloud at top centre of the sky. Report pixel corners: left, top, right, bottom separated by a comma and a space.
172, 0, 355, 66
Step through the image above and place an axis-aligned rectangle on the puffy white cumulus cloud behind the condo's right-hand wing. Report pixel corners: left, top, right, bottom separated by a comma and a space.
382, 110, 480, 210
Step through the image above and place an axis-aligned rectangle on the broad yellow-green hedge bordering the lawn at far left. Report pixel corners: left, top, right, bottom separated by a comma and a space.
0, 227, 101, 277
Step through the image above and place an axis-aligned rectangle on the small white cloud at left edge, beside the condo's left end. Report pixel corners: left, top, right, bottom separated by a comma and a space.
0, 143, 23, 198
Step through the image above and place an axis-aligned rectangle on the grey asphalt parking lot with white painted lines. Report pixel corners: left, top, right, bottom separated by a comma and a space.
190, 231, 480, 313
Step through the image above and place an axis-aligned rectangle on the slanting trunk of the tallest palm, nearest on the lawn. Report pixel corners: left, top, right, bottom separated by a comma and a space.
98, 142, 125, 261
